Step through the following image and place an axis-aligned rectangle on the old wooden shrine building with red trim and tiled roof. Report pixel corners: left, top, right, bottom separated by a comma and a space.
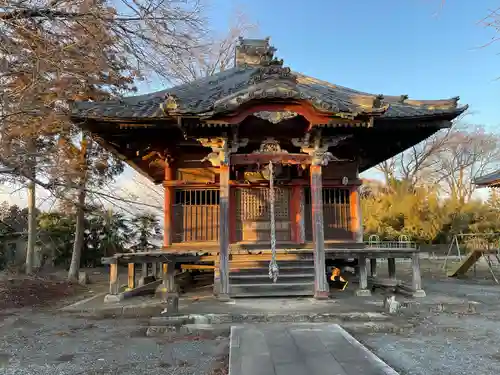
73, 39, 466, 297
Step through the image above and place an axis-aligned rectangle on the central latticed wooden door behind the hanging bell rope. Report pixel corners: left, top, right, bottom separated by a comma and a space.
236, 187, 291, 243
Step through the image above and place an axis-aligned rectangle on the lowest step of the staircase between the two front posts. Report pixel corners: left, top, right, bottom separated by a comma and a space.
229, 278, 314, 297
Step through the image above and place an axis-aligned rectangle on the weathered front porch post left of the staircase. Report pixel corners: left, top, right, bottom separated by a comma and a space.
219, 163, 230, 299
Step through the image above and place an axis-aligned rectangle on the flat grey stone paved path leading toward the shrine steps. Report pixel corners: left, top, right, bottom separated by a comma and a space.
229, 324, 398, 375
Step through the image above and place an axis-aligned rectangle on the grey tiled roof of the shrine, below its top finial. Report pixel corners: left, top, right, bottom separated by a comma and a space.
73, 61, 467, 119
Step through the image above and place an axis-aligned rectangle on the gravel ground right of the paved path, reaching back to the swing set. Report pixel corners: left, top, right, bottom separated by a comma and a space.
353, 263, 500, 375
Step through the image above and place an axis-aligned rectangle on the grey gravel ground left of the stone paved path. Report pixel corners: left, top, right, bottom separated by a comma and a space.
0, 312, 228, 375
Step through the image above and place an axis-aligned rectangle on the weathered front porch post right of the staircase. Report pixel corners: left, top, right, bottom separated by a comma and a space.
311, 165, 329, 299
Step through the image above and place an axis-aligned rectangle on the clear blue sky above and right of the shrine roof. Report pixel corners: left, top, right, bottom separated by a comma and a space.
201, 0, 500, 130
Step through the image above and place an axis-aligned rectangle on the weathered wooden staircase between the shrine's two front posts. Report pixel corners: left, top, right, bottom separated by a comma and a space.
229, 257, 314, 297
